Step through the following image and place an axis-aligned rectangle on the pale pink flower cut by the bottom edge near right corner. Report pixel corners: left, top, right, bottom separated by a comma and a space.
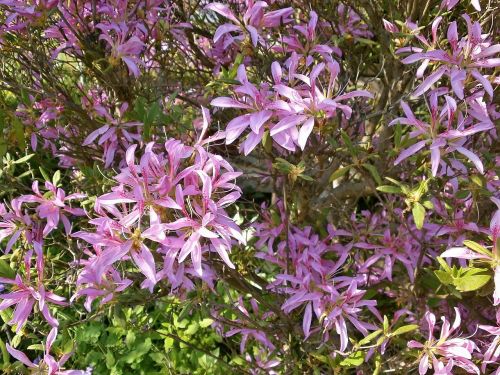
408, 308, 479, 375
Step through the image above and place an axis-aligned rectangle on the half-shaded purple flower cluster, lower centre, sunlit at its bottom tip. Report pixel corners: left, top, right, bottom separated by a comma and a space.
264, 228, 379, 351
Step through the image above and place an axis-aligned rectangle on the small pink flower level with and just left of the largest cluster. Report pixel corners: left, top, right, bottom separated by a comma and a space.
19, 181, 86, 236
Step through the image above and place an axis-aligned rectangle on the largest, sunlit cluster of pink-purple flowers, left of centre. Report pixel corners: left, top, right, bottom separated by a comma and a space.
73, 140, 244, 308
